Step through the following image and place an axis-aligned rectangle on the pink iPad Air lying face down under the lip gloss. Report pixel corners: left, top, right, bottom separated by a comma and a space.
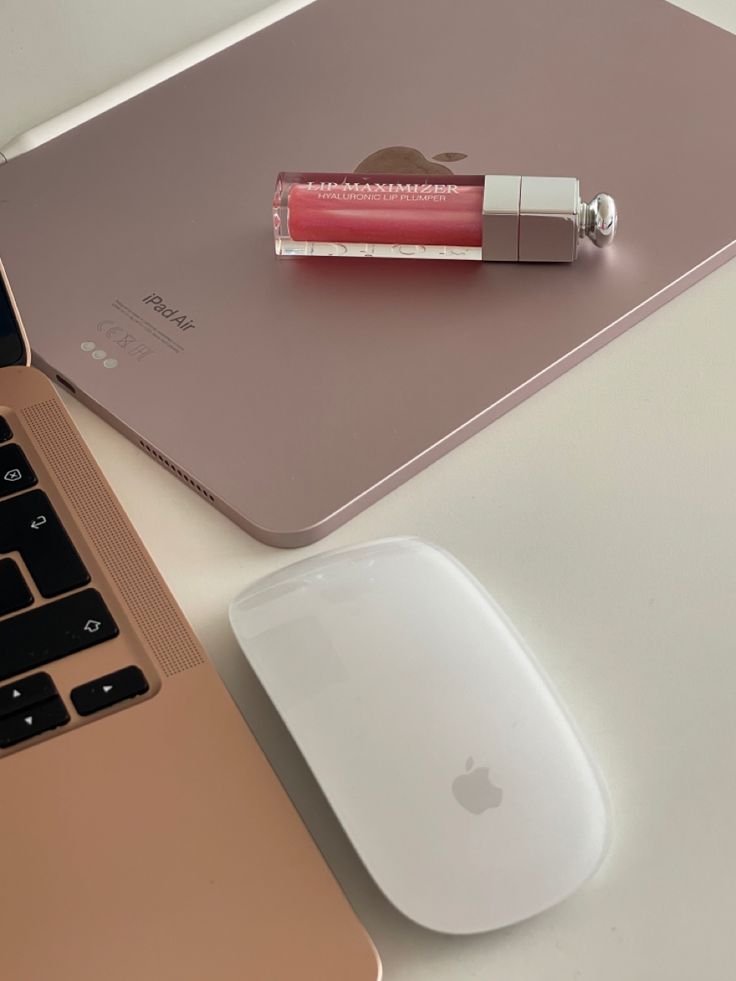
0, 0, 736, 546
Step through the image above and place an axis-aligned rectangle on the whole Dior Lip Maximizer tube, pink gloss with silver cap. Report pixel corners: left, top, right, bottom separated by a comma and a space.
273, 173, 617, 262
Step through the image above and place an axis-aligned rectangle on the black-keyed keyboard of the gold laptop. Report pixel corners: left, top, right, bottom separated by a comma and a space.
0, 416, 149, 750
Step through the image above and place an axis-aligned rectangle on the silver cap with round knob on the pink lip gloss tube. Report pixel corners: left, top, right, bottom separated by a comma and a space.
483, 175, 618, 262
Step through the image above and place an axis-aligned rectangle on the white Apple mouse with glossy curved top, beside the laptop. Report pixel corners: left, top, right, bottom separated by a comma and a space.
230, 538, 609, 933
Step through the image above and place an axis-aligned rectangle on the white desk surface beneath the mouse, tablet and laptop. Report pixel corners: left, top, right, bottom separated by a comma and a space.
0, 0, 736, 981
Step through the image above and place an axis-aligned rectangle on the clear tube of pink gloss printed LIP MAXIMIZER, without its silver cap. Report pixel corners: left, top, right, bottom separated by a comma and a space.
274, 174, 483, 259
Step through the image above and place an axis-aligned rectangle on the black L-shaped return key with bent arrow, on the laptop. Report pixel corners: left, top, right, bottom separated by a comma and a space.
0, 490, 89, 599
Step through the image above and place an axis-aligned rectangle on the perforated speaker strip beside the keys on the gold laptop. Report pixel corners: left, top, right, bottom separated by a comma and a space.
23, 400, 205, 676
